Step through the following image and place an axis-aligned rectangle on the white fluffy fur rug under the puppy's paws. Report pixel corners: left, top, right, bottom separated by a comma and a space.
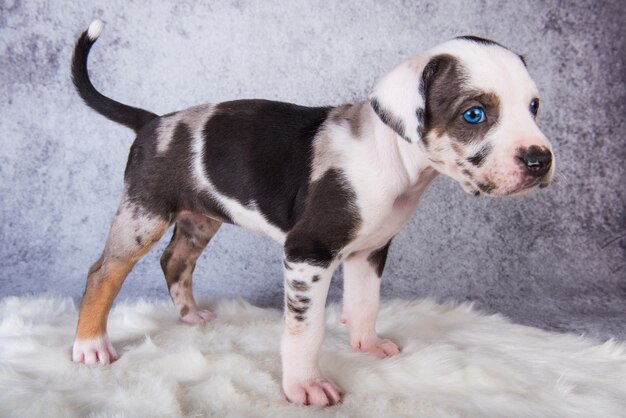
0, 297, 626, 418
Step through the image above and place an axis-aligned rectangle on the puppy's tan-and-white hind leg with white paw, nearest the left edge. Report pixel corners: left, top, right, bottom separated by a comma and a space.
72, 200, 169, 364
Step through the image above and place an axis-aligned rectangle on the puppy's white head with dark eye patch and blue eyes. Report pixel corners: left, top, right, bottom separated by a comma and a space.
370, 37, 554, 196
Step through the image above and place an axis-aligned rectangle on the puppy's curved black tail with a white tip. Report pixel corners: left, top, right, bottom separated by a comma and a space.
72, 20, 158, 132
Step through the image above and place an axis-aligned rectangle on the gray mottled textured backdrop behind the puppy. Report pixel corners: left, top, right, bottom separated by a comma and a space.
0, 0, 626, 339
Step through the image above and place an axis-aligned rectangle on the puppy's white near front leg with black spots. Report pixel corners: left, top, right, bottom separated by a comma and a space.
281, 259, 341, 406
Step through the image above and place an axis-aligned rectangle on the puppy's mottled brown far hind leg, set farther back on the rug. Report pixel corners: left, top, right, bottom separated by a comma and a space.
161, 212, 221, 324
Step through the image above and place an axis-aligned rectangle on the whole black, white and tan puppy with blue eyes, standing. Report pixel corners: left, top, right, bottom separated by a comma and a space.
72, 21, 554, 405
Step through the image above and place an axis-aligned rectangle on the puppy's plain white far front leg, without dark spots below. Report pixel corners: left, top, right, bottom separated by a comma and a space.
342, 241, 400, 358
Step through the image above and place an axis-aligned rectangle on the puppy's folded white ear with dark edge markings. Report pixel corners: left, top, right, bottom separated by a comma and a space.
369, 55, 452, 144
